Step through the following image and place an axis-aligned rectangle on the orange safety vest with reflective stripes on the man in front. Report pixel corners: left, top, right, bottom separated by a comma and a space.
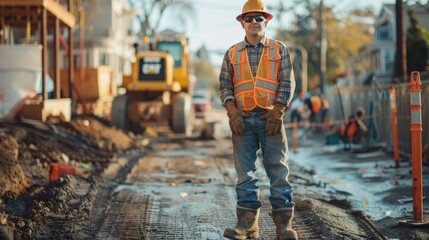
229, 38, 281, 110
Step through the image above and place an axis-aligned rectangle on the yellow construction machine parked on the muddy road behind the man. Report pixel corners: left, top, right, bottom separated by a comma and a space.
111, 30, 195, 135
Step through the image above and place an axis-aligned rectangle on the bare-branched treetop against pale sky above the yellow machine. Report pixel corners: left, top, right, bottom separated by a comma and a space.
130, 0, 195, 37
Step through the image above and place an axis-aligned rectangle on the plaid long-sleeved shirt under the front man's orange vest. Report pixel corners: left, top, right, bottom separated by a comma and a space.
219, 37, 295, 108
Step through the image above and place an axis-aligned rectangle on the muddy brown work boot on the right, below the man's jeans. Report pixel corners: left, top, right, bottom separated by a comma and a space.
271, 207, 298, 240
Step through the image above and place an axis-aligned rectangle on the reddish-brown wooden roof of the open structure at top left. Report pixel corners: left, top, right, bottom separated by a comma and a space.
0, 0, 76, 28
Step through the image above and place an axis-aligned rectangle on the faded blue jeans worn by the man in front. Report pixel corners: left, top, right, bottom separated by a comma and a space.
232, 112, 295, 209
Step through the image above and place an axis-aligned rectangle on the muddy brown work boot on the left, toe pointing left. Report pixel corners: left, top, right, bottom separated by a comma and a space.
223, 206, 259, 239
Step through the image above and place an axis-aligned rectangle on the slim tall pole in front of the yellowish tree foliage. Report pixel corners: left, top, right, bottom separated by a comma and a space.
319, 0, 327, 94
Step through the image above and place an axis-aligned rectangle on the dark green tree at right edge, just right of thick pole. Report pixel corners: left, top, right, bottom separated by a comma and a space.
407, 9, 429, 74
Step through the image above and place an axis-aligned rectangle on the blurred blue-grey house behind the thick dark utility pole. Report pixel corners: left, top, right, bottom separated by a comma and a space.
349, 3, 429, 85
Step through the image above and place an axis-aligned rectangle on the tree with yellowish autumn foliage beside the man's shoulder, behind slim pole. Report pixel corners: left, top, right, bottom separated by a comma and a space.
277, 1, 374, 90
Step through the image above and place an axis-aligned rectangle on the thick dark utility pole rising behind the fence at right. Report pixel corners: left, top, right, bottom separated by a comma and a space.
394, 0, 407, 82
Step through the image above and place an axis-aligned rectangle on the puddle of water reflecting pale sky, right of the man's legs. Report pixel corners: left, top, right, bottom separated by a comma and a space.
291, 142, 424, 220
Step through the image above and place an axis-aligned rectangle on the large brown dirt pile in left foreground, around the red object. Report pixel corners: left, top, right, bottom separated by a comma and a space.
0, 115, 138, 239
